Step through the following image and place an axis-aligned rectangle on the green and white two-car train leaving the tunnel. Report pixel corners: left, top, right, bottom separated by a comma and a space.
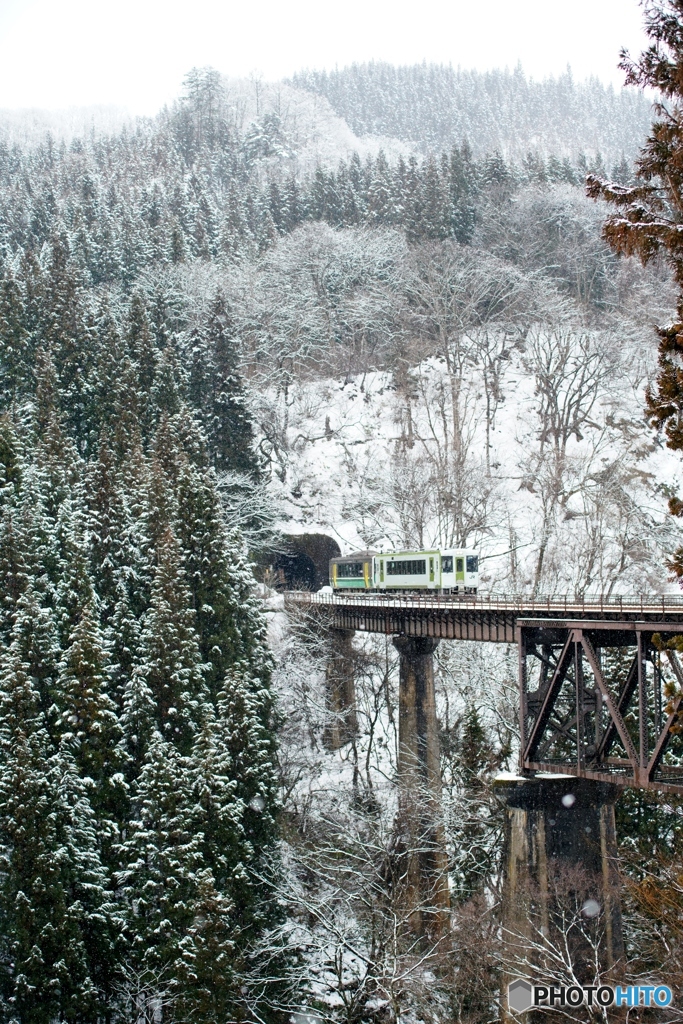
330, 548, 479, 594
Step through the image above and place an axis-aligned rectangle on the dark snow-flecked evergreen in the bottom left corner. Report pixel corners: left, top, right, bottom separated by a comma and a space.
0, 656, 117, 1024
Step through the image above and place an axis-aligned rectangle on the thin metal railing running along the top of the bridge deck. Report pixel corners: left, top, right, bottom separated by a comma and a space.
285, 591, 683, 616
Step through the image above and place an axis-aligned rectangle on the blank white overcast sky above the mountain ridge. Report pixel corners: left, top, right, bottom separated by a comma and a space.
0, 0, 645, 114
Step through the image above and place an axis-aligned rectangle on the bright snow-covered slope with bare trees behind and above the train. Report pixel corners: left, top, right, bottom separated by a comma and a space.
258, 348, 682, 593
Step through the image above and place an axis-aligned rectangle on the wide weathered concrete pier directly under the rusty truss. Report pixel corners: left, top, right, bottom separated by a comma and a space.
496, 775, 624, 1002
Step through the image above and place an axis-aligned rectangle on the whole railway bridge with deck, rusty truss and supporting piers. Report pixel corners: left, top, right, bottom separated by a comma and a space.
285, 592, 683, 968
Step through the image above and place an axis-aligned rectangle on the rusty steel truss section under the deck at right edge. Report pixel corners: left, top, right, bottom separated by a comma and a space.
516, 618, 683, 794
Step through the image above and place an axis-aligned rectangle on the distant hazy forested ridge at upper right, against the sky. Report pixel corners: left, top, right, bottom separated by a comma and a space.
292, 61, 651, 164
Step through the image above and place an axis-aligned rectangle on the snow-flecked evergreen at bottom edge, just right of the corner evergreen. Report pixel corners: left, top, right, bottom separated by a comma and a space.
121, 732, 233, 1020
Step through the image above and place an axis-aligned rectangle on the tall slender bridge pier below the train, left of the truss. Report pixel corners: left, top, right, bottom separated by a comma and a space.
393, 636, 450, 941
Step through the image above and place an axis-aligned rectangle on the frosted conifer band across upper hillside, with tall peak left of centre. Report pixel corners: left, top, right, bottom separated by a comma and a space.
0, 74, 618, 288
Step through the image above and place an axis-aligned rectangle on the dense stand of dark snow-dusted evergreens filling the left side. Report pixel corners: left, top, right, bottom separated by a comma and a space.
0, 238, 276, 1024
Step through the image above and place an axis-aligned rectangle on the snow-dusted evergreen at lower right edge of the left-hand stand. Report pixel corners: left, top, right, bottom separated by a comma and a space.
181, 670, 286, 1020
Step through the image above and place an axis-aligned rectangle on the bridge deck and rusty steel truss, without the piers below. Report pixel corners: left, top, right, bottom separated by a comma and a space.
285, 592, 683, 794
